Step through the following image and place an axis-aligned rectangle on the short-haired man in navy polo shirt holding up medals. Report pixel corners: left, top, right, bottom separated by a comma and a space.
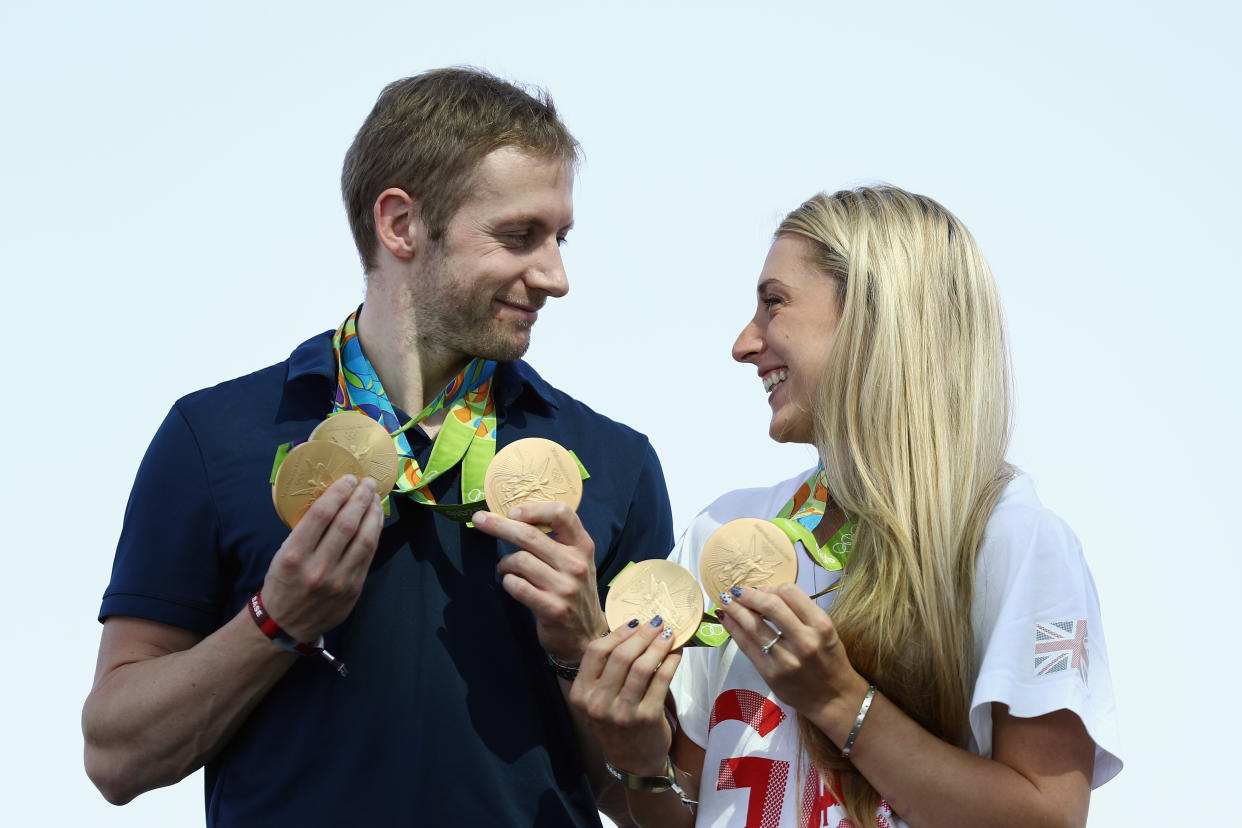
83, 70, 672, 826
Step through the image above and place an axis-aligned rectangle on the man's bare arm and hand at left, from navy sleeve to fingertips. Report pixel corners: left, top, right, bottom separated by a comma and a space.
82, 474, 384, 803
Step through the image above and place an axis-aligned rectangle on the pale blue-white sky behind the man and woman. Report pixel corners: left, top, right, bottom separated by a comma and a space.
0, 1, 1242, 827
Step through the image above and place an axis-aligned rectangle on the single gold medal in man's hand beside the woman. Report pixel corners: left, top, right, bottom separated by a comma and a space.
483, 437, 582, 531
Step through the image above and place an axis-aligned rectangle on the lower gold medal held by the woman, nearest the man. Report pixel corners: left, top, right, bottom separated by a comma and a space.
604, 560, 703, 648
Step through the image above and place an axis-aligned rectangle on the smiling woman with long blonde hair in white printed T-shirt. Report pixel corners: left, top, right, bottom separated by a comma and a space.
571, 186, 1122, 828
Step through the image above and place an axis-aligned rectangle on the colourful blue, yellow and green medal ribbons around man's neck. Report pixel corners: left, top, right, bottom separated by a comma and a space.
329, 310, 496, 509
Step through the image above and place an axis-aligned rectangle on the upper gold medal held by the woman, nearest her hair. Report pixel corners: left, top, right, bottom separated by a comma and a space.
699, 518, 797, 605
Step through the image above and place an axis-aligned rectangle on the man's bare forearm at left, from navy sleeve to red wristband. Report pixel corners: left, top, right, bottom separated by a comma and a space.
82, 611, 297, 804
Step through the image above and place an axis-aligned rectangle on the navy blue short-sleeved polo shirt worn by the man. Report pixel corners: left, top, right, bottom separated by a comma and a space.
99, 334, 672, 827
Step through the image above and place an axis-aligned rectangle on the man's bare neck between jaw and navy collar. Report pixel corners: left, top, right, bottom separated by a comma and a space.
358, 299, 469, 422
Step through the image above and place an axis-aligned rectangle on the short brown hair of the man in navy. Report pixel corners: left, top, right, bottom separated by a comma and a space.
340, 67, 579, 271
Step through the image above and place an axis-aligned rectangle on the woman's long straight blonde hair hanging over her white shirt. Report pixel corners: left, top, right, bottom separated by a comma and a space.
776, 186, 1012, 826
